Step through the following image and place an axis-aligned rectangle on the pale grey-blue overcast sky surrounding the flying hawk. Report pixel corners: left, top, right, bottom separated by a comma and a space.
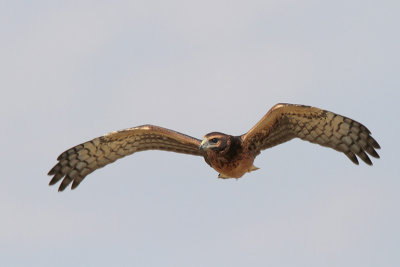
0, 0, 400, 267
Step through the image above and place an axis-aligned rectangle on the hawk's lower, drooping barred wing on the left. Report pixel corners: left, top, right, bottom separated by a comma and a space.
48, 125, 203, 191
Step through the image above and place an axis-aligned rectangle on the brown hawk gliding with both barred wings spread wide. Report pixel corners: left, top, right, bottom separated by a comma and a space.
48, 104, 380, 191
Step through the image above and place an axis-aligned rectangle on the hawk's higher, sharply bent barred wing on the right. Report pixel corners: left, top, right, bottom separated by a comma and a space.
242, 104, 380, 165
